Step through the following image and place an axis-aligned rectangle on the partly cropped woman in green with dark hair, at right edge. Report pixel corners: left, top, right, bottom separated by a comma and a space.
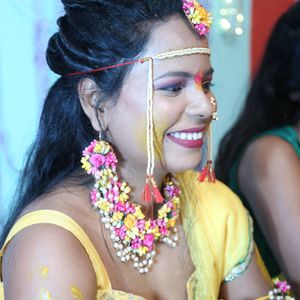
216, 2, 300, 297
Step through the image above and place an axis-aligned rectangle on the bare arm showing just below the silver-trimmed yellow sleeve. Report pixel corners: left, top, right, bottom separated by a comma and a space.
219, 251, 272, 300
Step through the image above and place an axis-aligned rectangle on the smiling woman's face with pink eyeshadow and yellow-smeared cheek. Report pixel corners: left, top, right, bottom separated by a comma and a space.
106, 17, 213, 173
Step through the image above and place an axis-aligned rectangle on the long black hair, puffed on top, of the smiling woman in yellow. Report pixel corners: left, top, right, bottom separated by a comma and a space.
1, 0, 186, 245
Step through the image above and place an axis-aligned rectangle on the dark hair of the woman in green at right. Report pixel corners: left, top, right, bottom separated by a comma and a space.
216, 2, 300, 183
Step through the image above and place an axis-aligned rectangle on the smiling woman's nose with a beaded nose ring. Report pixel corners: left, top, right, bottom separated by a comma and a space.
185, 90, 217, 121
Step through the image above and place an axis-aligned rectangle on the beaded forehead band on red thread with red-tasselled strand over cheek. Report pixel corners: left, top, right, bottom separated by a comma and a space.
66, 47, 210, 203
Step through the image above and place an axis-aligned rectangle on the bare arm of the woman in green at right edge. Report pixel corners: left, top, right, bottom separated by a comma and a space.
238, 136, 300, 297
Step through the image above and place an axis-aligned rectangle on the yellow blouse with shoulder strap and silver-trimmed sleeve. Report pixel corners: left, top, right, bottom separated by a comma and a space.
0, 171, 253, 300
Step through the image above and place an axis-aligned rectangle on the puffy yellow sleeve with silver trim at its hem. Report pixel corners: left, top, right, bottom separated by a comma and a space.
190, 178, 254, 282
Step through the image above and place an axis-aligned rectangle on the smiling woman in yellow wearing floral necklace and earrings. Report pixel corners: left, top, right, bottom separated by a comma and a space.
0, 0, 282, 300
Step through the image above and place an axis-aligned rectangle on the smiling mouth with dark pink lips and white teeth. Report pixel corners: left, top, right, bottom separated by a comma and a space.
167, 128, 205, 148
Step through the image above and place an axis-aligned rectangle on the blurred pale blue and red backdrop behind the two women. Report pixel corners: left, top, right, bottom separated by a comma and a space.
0, 0, 294, 225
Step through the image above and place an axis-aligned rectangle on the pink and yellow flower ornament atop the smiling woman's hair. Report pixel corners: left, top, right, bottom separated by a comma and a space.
182, 0, 212, 36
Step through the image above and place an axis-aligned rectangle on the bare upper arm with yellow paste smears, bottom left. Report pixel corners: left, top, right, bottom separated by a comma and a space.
3, 225, 97, 300
